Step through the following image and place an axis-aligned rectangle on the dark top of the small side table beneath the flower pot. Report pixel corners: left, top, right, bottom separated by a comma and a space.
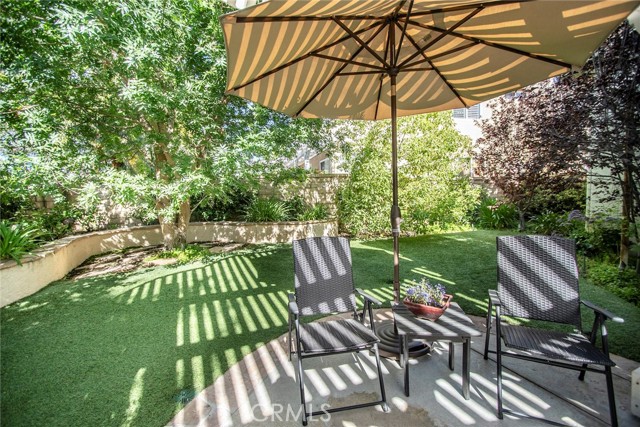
393, 302, 482, 340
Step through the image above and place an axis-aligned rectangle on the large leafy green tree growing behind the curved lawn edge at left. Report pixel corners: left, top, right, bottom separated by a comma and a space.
0, 0, 324, 247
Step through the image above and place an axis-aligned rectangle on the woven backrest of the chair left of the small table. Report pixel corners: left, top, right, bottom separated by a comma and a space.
293, 237, 356, 316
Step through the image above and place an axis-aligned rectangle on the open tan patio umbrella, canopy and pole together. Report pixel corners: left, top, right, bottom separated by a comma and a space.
220, 0, 640, 301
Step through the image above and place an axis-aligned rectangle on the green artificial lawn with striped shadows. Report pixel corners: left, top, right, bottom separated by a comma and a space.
0, 231, 640, 427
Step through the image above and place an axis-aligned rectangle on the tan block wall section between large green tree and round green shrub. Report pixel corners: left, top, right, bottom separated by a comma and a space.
258, 174, 348, 216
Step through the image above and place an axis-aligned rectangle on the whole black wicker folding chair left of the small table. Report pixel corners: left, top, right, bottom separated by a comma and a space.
289, 237, 388, 425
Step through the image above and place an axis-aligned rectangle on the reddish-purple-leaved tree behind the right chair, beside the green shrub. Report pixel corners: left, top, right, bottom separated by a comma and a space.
477, 81, 584, 230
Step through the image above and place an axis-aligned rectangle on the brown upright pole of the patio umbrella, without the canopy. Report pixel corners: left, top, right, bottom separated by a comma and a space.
389, 71, 402, 303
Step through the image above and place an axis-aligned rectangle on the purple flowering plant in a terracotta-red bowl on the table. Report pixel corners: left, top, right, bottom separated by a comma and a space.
403, 278, 453, 320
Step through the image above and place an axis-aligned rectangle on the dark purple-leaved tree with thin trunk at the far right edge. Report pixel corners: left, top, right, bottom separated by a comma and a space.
566, 23, 640, 268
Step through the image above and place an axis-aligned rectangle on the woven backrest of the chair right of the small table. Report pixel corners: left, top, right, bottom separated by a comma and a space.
497, 235, 581, 329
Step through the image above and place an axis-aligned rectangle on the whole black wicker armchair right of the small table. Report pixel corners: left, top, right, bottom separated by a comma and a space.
484, 235, 623, 426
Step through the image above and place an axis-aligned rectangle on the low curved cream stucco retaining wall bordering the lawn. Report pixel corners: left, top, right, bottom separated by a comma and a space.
0, 220, 338, 307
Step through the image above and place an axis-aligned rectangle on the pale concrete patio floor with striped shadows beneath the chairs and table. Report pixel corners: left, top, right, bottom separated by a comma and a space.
168, 310, 640, 427
